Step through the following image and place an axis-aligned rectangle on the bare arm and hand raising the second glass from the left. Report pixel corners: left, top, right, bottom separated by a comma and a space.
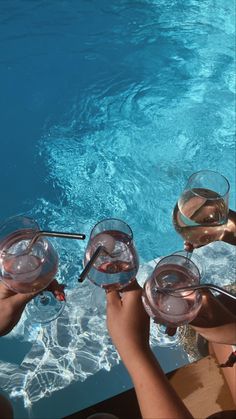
106, 282, 192, 419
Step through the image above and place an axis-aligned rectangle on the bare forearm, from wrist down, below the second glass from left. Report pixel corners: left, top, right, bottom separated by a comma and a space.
122, 350, 192, 419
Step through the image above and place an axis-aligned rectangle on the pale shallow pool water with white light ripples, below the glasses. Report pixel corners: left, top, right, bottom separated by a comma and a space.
0, 243, 236, 407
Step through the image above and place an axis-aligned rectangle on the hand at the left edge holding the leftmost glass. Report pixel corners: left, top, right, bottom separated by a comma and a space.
0, 279, 65, 336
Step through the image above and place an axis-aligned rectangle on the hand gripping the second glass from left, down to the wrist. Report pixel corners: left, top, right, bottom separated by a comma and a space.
106, 283, 150, 367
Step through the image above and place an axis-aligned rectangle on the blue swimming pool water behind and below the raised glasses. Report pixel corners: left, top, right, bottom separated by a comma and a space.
0, 0, 235, 416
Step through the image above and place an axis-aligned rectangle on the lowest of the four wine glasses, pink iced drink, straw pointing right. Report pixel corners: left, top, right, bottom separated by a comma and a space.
142, 254, 202, 346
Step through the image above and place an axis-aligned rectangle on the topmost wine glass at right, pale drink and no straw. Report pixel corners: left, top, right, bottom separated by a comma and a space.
173, 170, 230, 247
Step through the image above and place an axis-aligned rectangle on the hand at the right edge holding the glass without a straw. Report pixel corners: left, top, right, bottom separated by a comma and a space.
184, 210, 236, 252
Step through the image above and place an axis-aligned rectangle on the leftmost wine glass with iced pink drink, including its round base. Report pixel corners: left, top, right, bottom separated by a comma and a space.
0, 216, 65, 323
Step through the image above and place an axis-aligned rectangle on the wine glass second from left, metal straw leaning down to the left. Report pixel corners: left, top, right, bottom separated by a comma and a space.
80, 218, 139, 308
